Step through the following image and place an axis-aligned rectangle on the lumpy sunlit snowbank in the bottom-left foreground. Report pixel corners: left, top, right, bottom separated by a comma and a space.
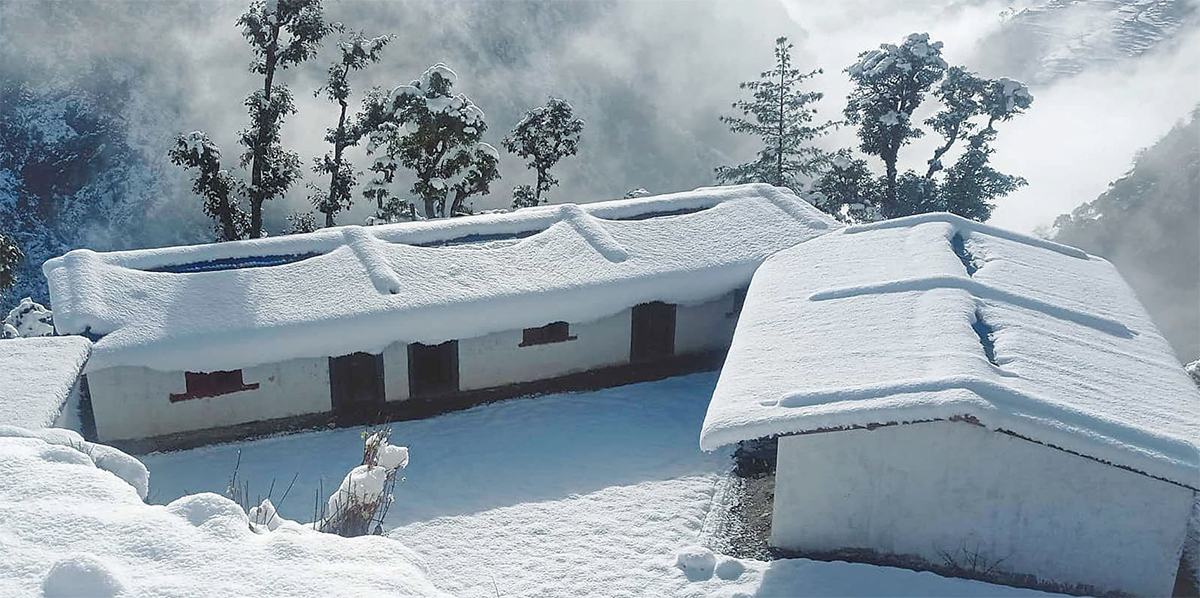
0, 429, 446, 598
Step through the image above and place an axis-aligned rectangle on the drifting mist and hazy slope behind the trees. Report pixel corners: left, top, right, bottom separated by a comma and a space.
0, 0, 1200, 336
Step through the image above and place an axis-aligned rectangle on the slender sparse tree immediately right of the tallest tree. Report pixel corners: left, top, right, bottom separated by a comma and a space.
310, 23, 392, 227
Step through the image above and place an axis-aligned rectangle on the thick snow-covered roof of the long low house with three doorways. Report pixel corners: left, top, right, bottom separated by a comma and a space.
43, 185, 840, 371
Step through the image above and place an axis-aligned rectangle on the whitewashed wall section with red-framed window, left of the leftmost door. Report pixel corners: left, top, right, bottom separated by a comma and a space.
88, 358, 331, 441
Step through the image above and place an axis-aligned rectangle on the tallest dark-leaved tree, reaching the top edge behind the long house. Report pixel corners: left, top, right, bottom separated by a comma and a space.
238, 0, 329, 239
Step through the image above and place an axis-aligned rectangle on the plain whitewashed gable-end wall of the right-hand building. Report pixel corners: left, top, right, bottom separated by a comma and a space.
770, 421, 1194, 596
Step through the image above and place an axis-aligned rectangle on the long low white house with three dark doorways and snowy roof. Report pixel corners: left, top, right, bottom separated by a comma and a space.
43, 185, 840, 447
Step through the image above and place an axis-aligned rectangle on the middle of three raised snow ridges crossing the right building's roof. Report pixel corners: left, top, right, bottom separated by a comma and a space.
809, 274, 1135, 339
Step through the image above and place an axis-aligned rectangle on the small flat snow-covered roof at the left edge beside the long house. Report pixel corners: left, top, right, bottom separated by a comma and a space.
0, 336, 91, 429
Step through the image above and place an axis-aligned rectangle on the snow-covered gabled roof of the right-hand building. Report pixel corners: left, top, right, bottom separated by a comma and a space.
701, 214, 1200, 488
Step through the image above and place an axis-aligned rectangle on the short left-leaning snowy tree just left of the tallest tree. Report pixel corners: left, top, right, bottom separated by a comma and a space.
169, 131, 250, 241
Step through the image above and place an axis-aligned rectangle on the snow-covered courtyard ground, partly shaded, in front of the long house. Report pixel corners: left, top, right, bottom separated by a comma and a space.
144, 372, 1060, 597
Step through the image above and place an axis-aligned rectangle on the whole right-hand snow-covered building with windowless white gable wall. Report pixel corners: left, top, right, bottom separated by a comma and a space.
701, 214, 1200, 596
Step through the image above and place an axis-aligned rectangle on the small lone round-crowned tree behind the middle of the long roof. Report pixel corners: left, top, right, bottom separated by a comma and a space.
503, 97, 583, 208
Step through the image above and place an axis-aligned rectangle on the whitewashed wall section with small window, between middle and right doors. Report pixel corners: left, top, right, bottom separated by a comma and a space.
458, 310, 631, 390
